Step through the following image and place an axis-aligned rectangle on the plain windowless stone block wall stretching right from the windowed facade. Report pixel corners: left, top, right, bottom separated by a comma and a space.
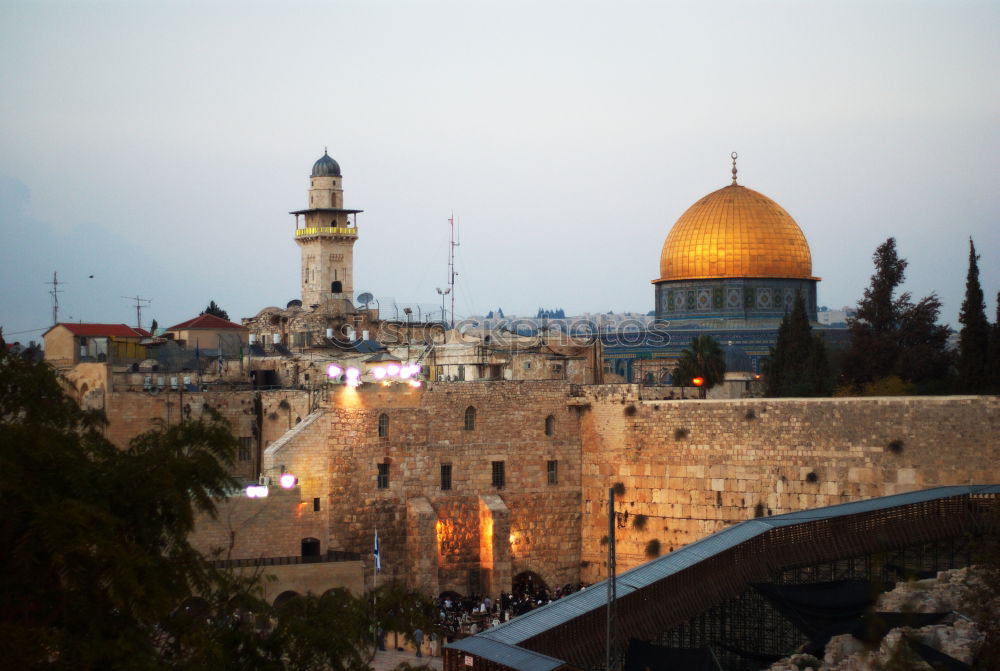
581, 392, 1000, 582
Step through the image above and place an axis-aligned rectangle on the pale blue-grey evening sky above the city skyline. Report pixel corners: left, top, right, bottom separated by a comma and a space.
0, 0, 1000, 341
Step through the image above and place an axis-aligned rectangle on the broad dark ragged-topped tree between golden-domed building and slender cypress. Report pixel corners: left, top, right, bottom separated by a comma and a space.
843, 238, 951, 391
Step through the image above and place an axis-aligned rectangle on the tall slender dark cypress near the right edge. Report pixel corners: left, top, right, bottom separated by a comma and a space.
957, 238, 990, 393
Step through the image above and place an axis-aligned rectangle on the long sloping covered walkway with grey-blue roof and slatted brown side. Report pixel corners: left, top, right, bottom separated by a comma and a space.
445, 485, 1000, 671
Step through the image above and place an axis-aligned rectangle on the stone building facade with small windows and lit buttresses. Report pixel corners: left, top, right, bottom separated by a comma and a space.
328, 381, 580, 594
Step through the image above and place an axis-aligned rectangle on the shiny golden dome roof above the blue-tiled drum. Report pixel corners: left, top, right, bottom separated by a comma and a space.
654, 184, 817, 282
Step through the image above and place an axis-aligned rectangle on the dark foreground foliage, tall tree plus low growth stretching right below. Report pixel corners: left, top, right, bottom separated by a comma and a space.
0, 340, 428, 671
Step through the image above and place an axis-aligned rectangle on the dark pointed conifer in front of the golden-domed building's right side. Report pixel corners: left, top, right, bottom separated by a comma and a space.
764, 294, 831, 396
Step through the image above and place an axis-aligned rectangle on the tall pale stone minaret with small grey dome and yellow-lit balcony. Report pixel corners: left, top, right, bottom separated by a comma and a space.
291, 150, 363, 307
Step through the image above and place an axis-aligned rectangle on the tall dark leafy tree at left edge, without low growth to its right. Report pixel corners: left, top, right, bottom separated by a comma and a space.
0, 348, 260, 669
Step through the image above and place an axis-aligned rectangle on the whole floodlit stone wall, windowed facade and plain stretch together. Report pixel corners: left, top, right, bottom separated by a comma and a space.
174, 381, 1000, 594
